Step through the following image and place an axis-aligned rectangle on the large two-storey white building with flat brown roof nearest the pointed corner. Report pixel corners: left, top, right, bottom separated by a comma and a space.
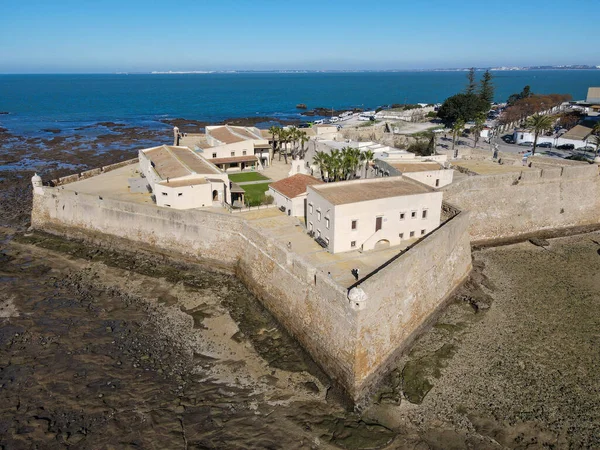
306, 177, 443, 253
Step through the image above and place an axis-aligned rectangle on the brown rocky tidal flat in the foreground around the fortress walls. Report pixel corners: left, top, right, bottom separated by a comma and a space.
0, 230, 600, 449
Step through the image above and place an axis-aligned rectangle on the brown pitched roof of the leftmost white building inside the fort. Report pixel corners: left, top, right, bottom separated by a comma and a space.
142, 145, 221, 180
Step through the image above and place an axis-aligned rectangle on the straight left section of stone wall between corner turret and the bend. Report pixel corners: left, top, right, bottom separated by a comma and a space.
32, 187, 242, 266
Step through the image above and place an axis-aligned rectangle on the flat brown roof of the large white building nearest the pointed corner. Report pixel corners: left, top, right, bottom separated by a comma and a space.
311, 177, 433, 205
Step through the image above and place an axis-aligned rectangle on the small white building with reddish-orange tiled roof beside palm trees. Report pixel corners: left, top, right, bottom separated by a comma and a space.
268, 174, 323, 218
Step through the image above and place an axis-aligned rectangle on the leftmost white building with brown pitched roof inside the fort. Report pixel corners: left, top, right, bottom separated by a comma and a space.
139, 145, 231, 209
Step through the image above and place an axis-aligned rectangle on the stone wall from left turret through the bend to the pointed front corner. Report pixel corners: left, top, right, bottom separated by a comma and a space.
32, 187, 356, 395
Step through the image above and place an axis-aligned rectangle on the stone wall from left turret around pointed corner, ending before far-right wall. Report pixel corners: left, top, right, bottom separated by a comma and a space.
32, 187, 471, 399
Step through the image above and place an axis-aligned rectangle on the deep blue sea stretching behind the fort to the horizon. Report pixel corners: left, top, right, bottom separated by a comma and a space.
0, 70, 600, 135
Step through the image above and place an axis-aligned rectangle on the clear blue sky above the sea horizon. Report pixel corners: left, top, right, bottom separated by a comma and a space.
0, 0, 600, 73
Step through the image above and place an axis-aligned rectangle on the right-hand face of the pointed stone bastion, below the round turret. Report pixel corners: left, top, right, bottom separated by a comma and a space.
355, 212, 472, 389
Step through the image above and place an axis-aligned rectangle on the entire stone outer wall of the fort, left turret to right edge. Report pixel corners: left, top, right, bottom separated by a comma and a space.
32, 151, 600, 400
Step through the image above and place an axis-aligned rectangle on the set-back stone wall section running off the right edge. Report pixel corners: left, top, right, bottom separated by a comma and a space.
442, 165, 600, 241
